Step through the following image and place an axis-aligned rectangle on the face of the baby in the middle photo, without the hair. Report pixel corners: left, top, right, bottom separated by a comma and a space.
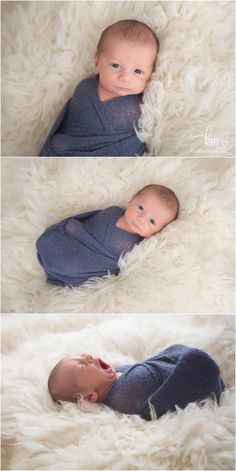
124, 190, 173, 237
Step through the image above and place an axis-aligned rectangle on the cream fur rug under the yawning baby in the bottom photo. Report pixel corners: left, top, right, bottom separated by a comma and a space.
2, 314, 235, 470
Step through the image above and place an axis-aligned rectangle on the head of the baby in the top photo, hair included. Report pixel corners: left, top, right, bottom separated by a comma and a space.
95, 20, 159, 100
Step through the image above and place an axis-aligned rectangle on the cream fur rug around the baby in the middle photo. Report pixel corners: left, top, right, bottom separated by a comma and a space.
2, 158, 234, 313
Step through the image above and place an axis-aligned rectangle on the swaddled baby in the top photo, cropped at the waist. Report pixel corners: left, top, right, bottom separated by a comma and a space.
40, 20, 159, 157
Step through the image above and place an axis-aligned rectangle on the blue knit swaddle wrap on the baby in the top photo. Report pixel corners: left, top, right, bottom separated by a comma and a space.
40, 75, 146, 157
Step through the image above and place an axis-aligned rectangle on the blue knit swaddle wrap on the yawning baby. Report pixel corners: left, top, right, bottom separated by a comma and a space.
103, 344, 225, 420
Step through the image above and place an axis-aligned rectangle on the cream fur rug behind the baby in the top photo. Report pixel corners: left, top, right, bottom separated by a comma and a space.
1, 1, 234, 156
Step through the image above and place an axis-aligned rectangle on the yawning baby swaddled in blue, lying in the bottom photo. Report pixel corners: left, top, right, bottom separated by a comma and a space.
48, 344, 224, 420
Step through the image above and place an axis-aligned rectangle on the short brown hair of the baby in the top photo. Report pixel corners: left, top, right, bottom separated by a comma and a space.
97, 20, 159, 55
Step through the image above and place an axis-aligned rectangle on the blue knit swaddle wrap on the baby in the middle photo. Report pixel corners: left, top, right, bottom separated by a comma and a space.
36, 206, 143, 286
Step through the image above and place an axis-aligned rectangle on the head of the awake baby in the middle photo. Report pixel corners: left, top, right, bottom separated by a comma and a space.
123, 184, 179, 237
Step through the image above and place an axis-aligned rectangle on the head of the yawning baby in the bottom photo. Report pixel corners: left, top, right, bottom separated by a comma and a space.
48, 354, 118, 402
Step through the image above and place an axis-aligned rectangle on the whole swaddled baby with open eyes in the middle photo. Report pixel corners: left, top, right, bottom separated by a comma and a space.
36, 185, 179, 286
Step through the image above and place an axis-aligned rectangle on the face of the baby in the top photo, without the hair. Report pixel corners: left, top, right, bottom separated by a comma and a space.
95, 36, 157, 100
